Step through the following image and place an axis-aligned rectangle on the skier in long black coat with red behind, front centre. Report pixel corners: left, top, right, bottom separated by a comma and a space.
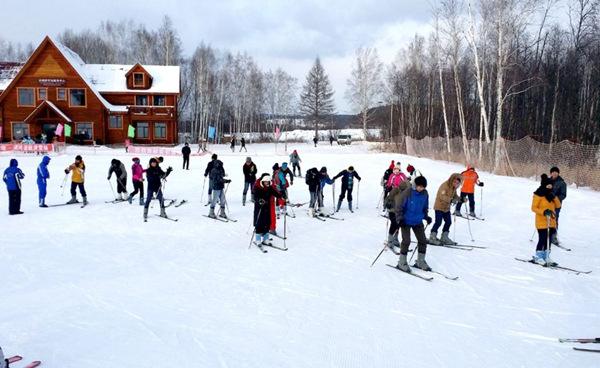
253, 173, 281, 245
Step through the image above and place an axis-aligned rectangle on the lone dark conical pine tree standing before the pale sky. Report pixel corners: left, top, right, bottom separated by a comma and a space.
300, 57, 335, 136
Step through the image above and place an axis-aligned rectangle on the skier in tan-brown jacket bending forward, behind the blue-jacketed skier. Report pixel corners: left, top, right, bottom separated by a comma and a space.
429, 173, 462, 245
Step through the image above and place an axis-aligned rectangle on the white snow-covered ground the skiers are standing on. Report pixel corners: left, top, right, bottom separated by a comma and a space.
0, 144, 600, 368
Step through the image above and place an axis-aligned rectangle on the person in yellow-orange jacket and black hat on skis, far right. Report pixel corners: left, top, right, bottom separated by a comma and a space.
531, 174, 560, 266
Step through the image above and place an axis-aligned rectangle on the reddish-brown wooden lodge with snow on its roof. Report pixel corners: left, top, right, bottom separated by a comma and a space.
0, 37, 180, 144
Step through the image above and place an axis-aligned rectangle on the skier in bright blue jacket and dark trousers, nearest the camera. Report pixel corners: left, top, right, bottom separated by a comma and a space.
396, 176, 431, 272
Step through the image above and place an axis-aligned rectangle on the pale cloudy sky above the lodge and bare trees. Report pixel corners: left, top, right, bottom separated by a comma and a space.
0, 0, 430, 113
